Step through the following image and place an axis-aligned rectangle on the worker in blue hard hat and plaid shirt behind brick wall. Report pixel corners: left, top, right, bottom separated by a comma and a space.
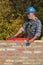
12, 7, 42, 46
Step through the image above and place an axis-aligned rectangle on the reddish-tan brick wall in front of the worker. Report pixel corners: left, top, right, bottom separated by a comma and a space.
0, 40, 43, 65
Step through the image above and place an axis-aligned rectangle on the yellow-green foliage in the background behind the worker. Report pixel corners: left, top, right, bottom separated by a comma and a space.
0, 0, 43, 39
